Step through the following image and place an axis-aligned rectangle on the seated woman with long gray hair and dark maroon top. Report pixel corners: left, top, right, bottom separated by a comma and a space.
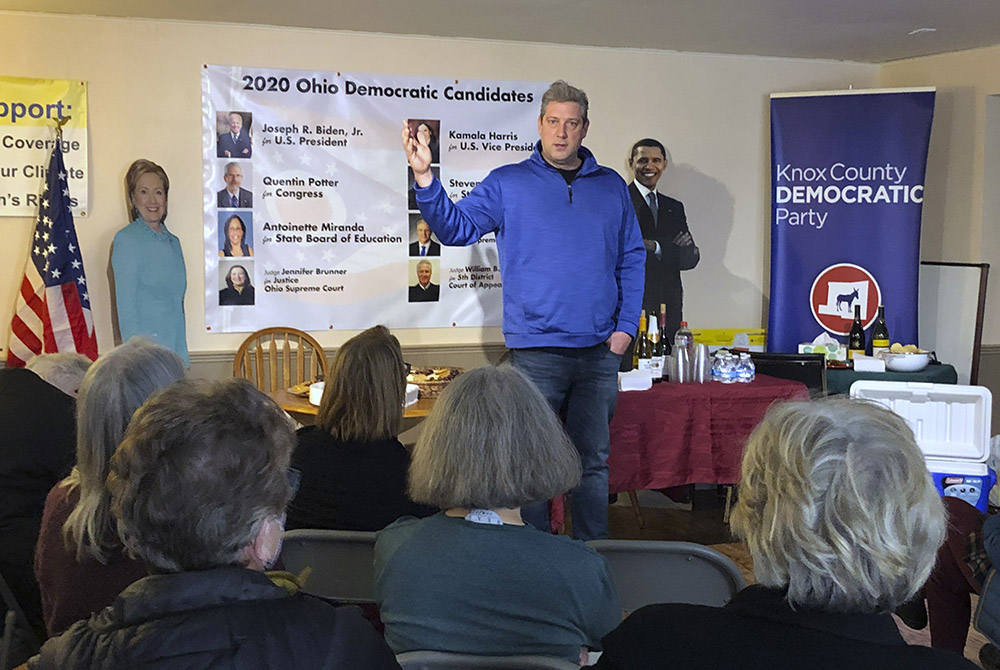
35, 337, 184, 635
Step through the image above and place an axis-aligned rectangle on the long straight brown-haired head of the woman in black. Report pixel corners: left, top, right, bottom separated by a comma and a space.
317, 326, 406, 442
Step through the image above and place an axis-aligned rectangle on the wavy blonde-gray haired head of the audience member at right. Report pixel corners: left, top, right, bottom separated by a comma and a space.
732, 400, 945, 612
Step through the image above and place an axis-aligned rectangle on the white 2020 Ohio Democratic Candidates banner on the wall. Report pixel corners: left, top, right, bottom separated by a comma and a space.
202, 66, 548, 332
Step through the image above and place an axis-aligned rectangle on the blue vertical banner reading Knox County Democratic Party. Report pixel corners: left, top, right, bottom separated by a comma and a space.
767, 88, 934, 351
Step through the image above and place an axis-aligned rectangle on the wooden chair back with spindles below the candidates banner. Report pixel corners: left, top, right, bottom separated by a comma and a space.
233, 326, 327, 393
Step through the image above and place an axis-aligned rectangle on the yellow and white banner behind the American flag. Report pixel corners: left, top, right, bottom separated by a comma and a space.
0, 77, 90, 217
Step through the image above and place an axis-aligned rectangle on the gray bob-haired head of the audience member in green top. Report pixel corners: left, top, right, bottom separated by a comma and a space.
410, 366, 580, 509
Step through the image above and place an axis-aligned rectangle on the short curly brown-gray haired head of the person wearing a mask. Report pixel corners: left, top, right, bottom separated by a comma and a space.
108, 379, 295, 572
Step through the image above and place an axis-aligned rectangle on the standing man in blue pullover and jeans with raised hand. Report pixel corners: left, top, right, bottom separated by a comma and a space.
402, 81, 646, 540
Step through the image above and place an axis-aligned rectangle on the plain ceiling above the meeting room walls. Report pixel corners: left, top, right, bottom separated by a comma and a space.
0, 0, 1000, 63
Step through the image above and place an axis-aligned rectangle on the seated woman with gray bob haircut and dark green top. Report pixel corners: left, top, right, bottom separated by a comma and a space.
375, 367, 621, 662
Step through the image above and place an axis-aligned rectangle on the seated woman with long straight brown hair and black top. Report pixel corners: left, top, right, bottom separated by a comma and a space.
286, 326, 437, 531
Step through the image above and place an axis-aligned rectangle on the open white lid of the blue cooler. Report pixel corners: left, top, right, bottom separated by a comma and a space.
851, 380, 993, 474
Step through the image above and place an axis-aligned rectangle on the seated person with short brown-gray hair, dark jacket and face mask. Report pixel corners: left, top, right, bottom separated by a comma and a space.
28, 379, 398, 670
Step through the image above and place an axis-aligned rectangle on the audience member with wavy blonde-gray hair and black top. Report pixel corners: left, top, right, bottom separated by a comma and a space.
594, 400, 976, 670
